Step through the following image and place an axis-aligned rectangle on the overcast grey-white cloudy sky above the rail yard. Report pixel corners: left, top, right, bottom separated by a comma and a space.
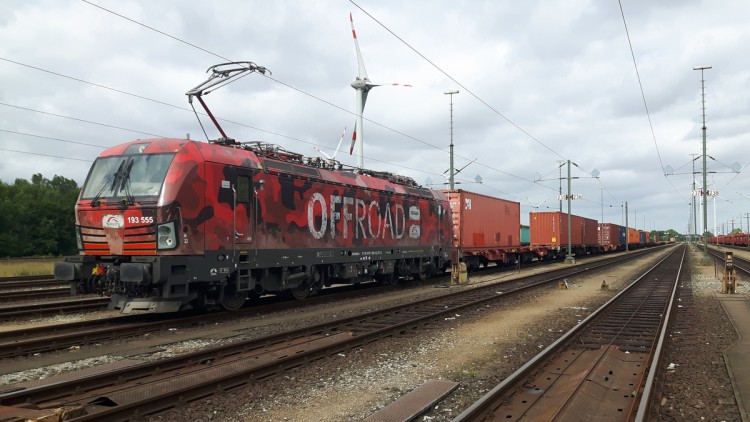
0, 0, 750, 233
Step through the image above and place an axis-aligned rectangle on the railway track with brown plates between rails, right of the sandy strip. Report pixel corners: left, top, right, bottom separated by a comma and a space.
454, 242, 686, 422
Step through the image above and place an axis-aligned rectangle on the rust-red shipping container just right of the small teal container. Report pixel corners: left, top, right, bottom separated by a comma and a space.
529, 211, 599, 247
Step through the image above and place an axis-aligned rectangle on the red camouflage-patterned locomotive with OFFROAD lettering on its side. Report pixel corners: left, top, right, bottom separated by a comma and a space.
55, 139, 451, 312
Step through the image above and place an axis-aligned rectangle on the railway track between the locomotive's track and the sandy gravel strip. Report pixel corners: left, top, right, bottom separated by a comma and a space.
0, 246, 668, 420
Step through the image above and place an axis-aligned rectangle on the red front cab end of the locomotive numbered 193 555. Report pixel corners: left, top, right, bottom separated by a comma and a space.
55, 140, 219, 312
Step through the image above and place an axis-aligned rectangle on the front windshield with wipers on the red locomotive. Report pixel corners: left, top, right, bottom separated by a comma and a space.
81, 154, 174, 202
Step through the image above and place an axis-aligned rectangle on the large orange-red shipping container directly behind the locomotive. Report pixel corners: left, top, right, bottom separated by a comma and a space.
443, 189, 521, 250
